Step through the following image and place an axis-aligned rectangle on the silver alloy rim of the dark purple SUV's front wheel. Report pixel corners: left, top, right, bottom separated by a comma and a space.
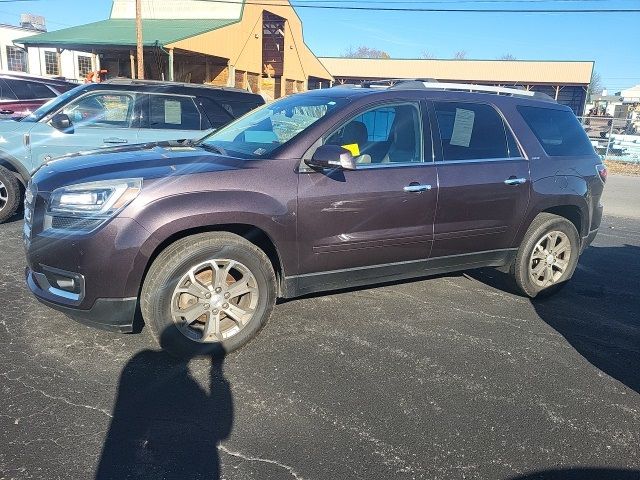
171, 259, 260, 343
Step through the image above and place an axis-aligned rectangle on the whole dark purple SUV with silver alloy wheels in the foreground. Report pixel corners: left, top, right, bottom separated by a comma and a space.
24, 81, 606, 354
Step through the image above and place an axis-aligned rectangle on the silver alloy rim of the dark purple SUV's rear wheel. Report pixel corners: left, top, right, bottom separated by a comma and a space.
529, 230, 571, 287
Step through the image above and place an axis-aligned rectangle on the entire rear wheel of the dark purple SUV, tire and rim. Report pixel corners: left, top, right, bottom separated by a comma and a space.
511, 213, 580, 298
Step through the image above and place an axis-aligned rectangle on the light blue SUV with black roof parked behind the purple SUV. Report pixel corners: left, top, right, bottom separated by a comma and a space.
0, 79, 264, 222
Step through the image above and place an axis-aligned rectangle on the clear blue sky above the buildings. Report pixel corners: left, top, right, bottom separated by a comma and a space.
0, 0, 640, 92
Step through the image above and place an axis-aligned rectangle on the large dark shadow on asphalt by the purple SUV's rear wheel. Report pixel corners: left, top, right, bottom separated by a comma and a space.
470, 245, 640, 396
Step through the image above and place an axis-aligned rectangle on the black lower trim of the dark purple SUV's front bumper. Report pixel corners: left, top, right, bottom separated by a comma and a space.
26, 267, 138, 333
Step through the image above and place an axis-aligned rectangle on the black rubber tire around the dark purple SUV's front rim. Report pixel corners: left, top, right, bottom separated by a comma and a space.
140, 232, 276, 358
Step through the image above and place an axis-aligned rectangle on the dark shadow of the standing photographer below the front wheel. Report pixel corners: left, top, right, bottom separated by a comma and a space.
95, 328, 233, 480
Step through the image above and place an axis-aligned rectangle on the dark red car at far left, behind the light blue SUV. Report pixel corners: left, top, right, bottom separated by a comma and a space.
0, 73, 78, 120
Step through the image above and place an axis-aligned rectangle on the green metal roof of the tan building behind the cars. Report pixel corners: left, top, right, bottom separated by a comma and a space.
14, 18, 238, 49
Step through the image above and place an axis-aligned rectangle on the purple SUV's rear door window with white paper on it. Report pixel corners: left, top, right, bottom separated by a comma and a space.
434, 102, 521, 161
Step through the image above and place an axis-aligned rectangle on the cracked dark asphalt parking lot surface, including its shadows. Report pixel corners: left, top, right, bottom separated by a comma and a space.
0, 177, 640, 480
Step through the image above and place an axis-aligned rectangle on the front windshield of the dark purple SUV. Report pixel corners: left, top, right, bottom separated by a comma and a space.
201, 94, 347, 158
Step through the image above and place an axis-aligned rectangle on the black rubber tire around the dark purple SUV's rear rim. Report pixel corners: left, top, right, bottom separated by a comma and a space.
510, 213, 580, 298
